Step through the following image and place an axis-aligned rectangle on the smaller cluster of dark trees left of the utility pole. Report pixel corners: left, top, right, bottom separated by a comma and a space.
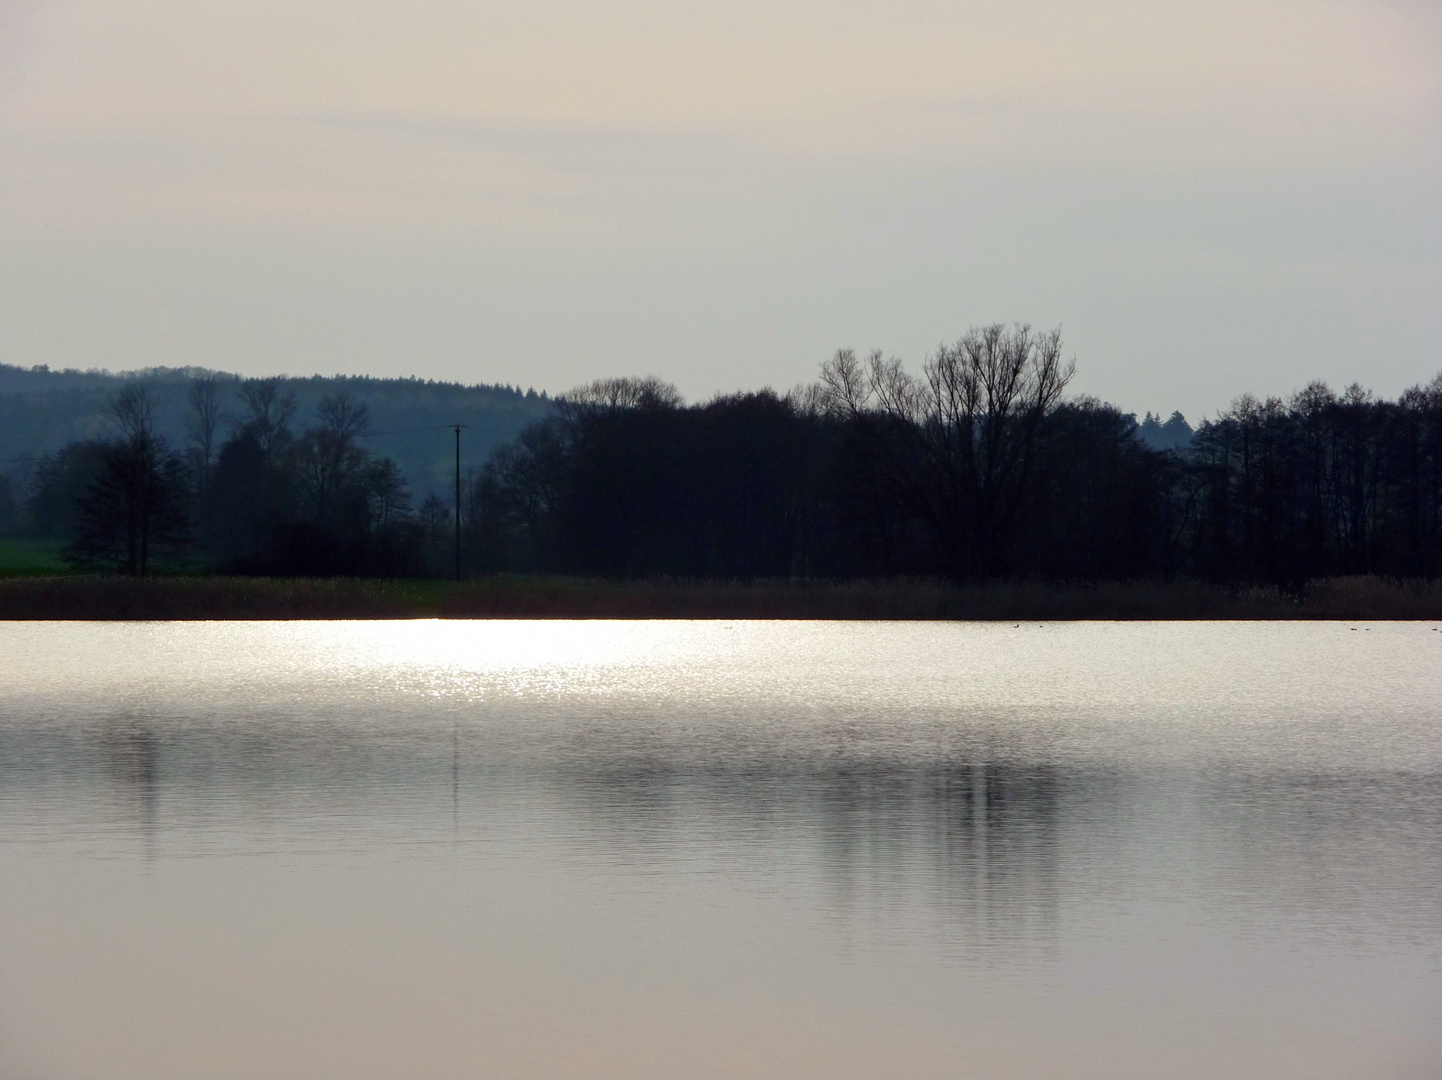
12, 375, 467, 577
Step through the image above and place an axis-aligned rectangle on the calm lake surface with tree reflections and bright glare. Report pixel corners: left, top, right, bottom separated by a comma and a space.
0, 621, 1442, 1080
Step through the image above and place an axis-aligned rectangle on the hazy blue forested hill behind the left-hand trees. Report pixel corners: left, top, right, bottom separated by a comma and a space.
0, 363, 552, 497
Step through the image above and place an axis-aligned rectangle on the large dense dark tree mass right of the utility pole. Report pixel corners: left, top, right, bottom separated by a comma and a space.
463, 327, 1442, 593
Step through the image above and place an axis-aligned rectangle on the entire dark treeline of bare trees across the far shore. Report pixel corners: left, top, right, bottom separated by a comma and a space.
0, 326, 1442, 588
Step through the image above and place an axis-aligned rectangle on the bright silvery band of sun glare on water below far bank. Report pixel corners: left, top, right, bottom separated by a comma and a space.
4, 620, 1442, 769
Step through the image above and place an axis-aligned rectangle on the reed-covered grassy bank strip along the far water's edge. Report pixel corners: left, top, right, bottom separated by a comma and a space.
0, 575, 1442, 621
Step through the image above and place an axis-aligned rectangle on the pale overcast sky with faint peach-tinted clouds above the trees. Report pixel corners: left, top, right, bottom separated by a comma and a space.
0, 0, 1442, 417
